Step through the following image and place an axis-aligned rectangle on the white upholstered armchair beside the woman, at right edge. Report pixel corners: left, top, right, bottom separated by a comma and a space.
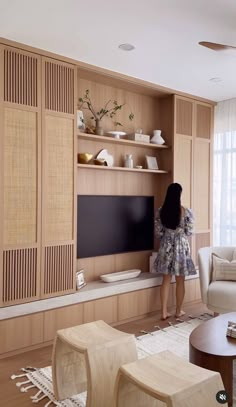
198, 247, 236, 314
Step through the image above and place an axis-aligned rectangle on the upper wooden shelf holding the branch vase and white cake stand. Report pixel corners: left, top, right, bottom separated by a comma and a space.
77, 133, 169, 150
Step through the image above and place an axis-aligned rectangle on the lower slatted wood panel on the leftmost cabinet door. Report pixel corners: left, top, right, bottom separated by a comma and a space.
2, 248, 38, 305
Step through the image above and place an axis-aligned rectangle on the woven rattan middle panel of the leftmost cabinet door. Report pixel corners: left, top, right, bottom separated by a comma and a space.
3, 108, 38, 245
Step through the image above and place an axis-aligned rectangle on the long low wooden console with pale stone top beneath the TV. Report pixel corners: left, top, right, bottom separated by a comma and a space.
0, 273, 200, 359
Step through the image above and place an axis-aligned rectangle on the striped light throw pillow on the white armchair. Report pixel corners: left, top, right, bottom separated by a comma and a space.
212, 253, 236, 281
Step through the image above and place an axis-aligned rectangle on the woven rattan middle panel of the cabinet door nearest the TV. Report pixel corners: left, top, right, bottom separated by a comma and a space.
43, 115, 74, 243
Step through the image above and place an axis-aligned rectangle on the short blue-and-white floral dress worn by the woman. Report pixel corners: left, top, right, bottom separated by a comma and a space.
154, 208, 196, 276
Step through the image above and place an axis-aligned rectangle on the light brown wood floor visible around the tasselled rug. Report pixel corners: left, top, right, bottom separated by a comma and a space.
0, 303, 209, 407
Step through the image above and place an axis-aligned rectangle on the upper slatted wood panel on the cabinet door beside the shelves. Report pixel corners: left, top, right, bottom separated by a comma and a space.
44, 61, 74, 114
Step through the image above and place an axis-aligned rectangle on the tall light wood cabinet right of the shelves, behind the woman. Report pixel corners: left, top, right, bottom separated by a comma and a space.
174, 96, 213, 263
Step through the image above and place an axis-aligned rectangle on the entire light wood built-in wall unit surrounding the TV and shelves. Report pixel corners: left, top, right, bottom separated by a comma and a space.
0, 39, 214, 353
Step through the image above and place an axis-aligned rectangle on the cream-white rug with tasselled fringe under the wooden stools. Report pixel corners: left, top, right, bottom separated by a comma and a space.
11, 314, 236, 407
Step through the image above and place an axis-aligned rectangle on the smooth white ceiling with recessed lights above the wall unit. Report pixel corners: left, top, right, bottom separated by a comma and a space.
0, 0, 236, 101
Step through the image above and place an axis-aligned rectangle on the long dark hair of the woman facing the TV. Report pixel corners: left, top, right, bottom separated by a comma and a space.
160, 182, 182, 229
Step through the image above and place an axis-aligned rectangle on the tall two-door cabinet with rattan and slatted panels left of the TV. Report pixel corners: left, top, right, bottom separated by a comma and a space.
0, 45, 75, 306
